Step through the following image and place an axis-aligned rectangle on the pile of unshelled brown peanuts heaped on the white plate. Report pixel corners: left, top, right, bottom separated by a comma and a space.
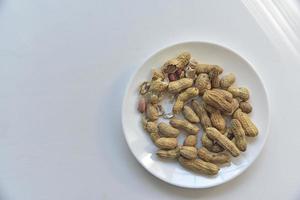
138, 52, 258, 175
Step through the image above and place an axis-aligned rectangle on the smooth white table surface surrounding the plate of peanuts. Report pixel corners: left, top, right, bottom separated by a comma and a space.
0, 0, 300, 200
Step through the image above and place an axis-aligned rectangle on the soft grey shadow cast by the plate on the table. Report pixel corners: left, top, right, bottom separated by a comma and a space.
99, 65, 268, 199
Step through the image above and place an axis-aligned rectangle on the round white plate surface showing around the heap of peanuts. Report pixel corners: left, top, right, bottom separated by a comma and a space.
122, 42, 270, 188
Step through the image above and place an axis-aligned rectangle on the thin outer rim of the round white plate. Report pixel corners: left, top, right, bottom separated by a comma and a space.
121, 40, 271, 189
